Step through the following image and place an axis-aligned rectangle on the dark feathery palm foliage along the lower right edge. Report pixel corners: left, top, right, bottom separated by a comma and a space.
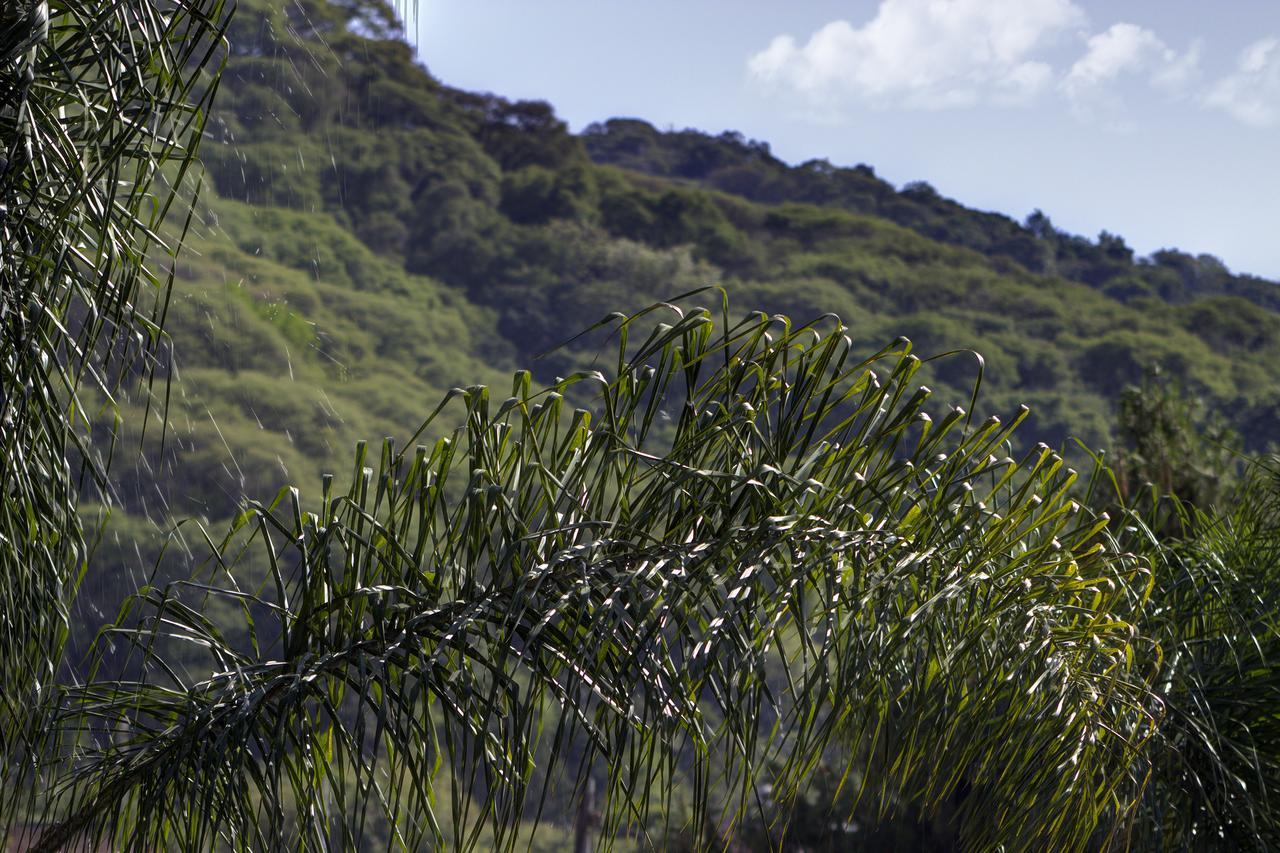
1130, 462, 1280, 849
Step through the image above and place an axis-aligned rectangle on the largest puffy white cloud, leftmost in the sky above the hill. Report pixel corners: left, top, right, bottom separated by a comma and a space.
748, 0, 1084, 109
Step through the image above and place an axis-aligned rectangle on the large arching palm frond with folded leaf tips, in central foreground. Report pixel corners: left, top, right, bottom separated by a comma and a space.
45, 302, 1151, 849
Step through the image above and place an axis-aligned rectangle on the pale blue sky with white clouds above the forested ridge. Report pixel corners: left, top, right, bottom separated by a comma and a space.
415, 0, 1280, 279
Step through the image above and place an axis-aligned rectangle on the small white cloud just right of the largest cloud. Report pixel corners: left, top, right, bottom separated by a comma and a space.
1062, 23, 1201, 119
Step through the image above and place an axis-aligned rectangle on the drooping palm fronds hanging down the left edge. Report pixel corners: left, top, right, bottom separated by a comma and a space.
0, 0, 225, 827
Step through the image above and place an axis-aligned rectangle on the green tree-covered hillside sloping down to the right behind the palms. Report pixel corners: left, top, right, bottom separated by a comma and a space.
102, 0, 1280, 525
